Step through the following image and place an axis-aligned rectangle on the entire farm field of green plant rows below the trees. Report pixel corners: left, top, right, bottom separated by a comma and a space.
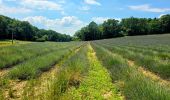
0, 34, 170, 100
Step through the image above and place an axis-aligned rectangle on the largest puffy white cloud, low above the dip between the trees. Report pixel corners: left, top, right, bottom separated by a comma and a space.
23, 16, 86, 35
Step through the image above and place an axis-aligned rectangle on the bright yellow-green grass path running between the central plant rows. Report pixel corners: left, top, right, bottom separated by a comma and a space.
66, 44, 123, 100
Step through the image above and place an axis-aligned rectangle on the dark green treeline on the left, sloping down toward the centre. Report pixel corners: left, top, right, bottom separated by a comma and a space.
0, 15, 72, 42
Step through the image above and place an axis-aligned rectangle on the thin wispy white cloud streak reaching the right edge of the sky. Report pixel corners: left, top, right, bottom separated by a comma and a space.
128, 4, 170, 13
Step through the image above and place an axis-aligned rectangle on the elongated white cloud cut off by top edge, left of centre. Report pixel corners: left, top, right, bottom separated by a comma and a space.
20, 0, 62, 10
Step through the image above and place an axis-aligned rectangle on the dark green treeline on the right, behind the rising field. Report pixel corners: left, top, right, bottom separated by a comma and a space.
74, 15, 170, 41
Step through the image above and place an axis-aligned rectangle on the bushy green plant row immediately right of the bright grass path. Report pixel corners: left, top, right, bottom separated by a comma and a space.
93, 44, 170, 100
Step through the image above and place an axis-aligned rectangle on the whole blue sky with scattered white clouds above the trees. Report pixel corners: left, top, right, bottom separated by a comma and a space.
0, 0, 170, 35
